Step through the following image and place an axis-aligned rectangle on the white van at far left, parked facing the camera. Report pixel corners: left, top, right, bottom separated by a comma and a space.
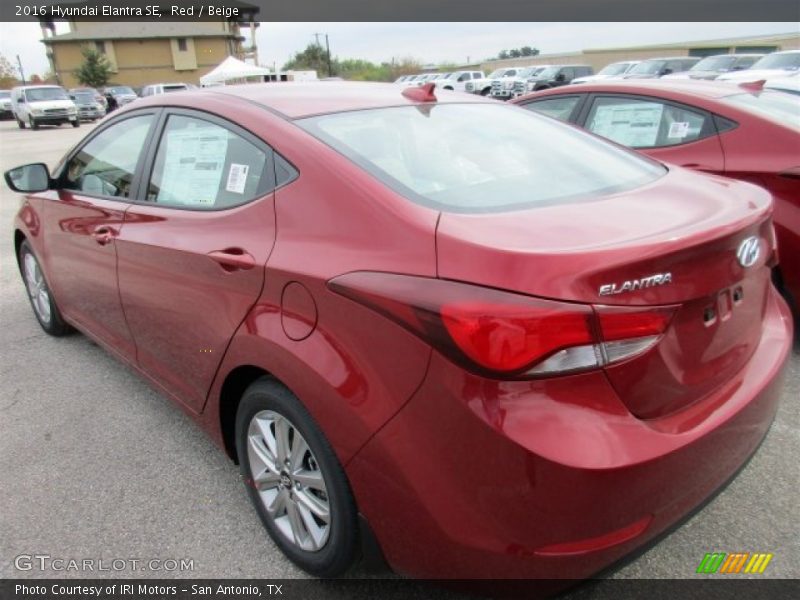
11, 85, 81, 129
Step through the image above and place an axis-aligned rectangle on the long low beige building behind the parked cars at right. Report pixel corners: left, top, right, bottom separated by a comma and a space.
480, 32, 800, 72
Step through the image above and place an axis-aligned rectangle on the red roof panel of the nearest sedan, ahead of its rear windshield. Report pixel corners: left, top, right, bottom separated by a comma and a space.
136, 81, 497, 119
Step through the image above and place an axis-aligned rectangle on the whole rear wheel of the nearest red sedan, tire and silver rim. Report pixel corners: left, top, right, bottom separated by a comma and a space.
236, 378, 358, 577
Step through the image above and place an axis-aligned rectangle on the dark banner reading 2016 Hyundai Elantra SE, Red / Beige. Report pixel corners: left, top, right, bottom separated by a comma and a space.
0, 0, 800, 23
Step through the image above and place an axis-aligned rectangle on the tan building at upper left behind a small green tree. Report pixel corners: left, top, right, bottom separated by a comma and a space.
41, 16, 258, 88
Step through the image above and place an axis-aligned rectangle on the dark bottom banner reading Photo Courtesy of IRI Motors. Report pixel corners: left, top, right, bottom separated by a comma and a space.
0, 575, 800, 600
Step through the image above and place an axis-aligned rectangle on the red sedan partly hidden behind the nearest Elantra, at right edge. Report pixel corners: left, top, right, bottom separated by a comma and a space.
515, 80, 800, 314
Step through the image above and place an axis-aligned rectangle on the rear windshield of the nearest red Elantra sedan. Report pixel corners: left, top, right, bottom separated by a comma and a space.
296, 104, 666, 212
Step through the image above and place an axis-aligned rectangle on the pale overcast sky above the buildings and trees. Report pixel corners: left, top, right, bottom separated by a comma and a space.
0, 22, 798, 75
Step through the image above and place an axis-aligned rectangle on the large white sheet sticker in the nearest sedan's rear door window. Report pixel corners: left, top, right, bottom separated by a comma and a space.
156, 123, 228, 206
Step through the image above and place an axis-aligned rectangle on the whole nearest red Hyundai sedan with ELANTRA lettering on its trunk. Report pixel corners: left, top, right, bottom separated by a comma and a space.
6, 83, 791, 578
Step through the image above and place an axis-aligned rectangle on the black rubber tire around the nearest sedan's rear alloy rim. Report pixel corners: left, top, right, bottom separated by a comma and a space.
236, 377, 359, 577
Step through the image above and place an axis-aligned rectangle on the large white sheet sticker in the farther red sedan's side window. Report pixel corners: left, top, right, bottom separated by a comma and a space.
589, 102, 664, 147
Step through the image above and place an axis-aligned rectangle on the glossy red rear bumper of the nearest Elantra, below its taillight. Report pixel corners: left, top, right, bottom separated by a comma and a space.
347, 291, 792, 579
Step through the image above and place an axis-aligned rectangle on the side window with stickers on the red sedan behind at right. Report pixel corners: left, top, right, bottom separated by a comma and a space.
585, 96, 715, 148
